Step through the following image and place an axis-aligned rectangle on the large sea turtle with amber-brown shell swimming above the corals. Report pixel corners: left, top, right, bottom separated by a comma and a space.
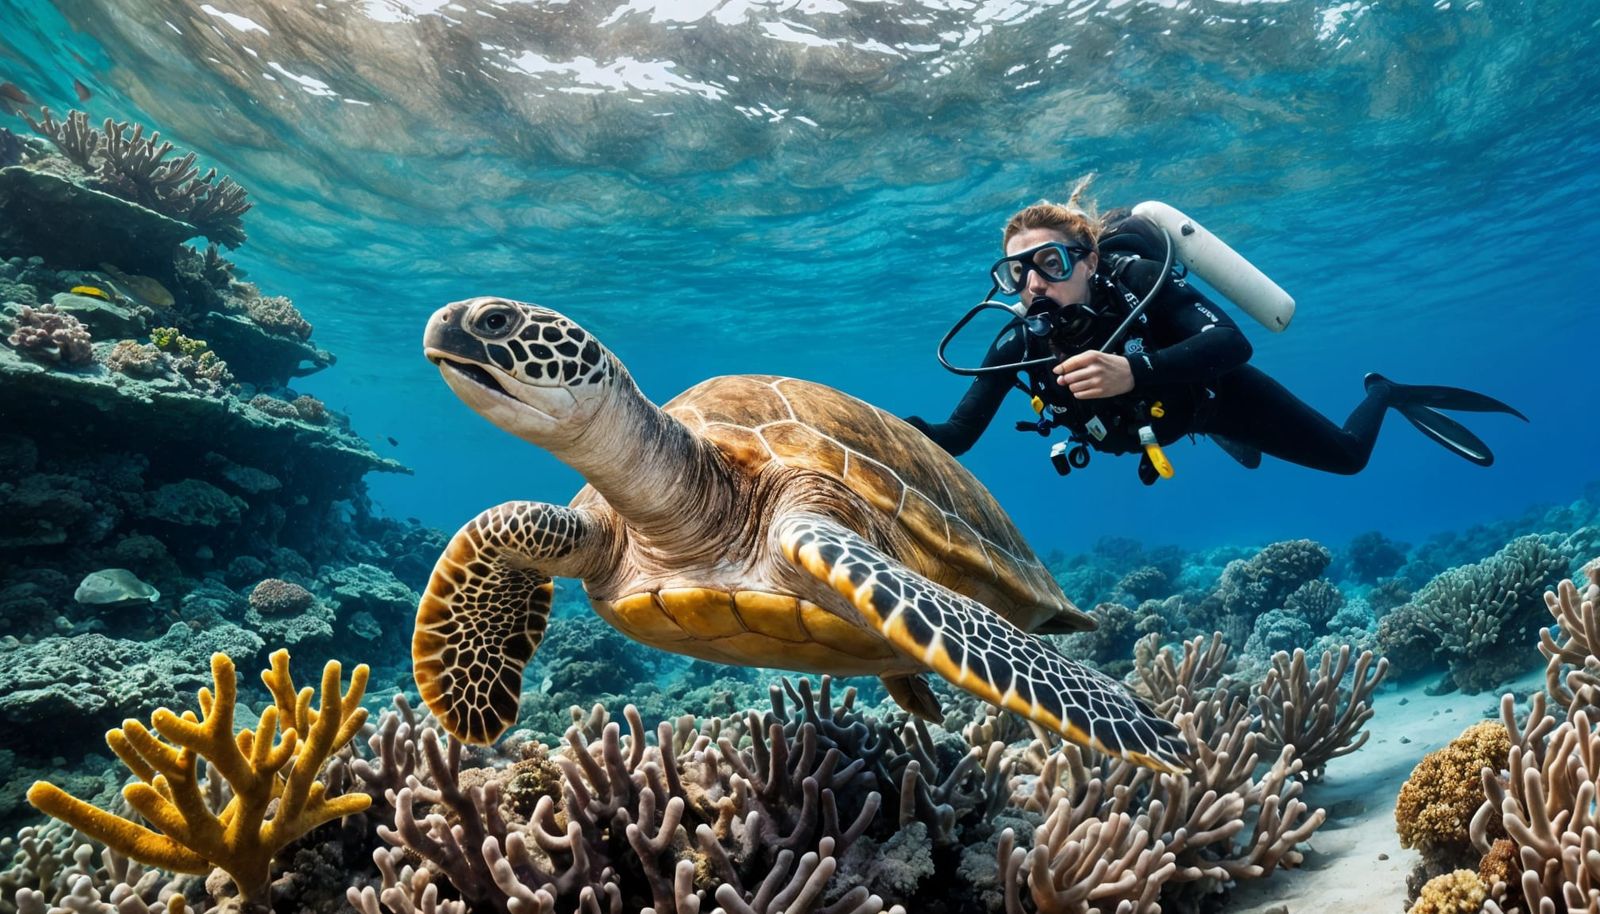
411, 298, 1187, 772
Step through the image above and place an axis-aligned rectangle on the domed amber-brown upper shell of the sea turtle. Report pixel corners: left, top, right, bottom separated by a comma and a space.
662, 375, 1094, 631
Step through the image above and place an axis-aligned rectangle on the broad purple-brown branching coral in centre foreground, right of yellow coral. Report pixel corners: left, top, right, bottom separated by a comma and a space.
361, 682, 934, 914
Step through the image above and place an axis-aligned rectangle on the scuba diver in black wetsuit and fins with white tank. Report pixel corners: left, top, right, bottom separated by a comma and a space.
906, 174, 1526, 485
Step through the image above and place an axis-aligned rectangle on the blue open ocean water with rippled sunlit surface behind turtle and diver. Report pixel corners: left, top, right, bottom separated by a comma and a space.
0, 0, 1600, 552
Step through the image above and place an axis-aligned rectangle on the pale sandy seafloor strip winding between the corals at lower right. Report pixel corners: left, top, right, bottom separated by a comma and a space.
1226, 665, 1544, 914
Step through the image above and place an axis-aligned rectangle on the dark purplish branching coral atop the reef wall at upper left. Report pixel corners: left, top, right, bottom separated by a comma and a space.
24, 107, 251, 248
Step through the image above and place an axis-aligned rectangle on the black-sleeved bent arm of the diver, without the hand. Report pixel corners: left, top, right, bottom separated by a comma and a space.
1128, 261, 1253, 389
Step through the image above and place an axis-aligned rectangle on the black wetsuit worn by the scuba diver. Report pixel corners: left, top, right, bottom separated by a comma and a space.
907, 259, 1389, 479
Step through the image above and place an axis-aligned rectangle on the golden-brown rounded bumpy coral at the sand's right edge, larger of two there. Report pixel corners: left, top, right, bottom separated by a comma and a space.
1395, 720, 1510, 869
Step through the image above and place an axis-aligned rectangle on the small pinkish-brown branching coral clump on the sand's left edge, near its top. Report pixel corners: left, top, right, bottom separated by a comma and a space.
1256, 645, 1389, 780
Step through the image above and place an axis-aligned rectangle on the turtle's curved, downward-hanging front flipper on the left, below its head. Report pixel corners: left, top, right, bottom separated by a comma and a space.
411, 501, 597, 744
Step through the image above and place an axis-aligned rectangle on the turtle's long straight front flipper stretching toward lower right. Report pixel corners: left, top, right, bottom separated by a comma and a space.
774, 514, 1189, 772
